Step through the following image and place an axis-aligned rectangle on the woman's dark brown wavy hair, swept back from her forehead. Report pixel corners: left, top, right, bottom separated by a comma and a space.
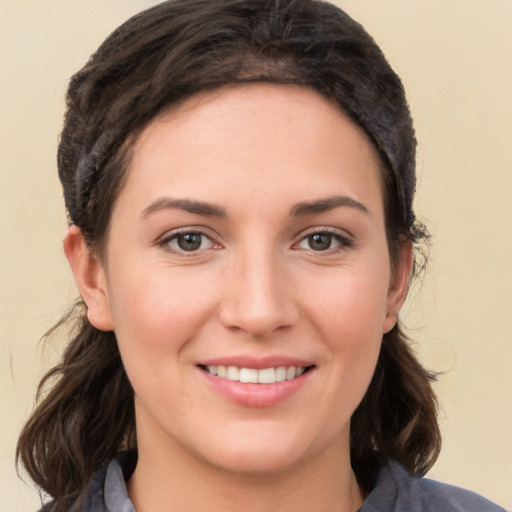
17, 0, 440, 512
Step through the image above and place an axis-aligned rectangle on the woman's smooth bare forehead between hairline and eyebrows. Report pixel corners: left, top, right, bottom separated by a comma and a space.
119, 83, 382, 219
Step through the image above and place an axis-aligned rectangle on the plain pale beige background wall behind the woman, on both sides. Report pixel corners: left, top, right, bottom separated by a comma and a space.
0, 0, 512, 512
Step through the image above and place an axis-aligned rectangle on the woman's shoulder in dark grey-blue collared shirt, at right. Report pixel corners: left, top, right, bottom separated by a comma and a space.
361, 462, 505, 512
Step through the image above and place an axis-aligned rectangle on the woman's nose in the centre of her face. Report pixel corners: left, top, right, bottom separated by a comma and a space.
220, 245, 299, 340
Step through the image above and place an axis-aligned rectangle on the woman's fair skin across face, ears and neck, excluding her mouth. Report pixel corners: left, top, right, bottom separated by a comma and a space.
64, 84, 411, 512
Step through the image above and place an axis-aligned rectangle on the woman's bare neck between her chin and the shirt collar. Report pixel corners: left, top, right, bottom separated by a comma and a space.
128, 430, 363, 512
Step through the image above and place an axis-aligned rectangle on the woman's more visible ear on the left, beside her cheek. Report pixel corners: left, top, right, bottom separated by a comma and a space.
64, 225, 113, 331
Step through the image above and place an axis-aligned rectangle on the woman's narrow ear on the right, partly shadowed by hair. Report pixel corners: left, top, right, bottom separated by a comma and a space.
383, 240, 414, 333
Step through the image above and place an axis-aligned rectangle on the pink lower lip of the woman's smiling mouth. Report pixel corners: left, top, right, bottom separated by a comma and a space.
199, 369, 314, 407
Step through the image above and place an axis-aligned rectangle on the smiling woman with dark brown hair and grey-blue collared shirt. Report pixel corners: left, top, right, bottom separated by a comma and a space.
18, 0, 501, 512
